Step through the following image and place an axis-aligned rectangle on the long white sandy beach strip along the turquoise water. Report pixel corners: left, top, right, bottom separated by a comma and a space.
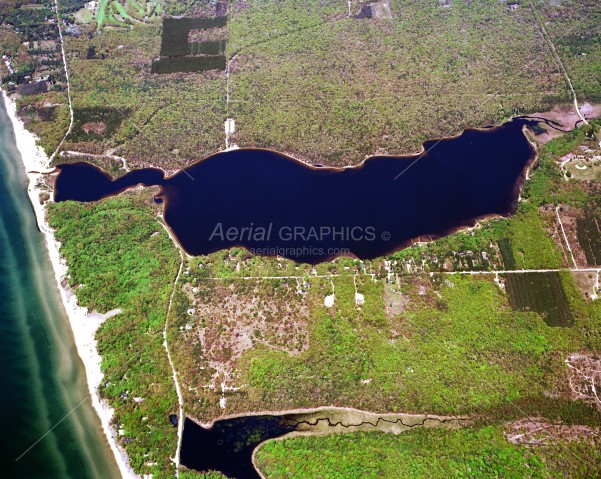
2, 91, 139, 478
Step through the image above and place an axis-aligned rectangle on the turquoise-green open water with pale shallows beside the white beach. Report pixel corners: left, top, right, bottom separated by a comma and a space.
0, 96, 119, 479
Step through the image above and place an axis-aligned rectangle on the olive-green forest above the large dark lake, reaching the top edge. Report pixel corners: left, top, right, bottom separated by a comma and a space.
7, 0, 601, 171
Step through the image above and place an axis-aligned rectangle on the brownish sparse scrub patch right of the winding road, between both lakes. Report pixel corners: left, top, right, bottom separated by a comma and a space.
171, 280, 310, 422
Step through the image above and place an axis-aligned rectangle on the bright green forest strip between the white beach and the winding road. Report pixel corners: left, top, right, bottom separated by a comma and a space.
48, 192, 179, 478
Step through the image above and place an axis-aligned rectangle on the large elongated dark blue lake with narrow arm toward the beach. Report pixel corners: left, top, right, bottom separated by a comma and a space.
55, 120, 535, 263
